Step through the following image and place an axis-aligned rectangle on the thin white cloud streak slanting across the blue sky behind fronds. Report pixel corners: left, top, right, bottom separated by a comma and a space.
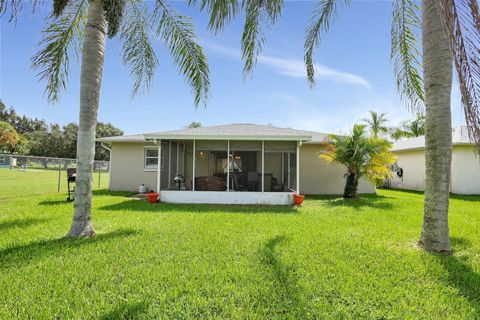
202, 42, 370, 89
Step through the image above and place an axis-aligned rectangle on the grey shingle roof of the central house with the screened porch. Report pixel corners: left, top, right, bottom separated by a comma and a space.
97, 123, 327, 143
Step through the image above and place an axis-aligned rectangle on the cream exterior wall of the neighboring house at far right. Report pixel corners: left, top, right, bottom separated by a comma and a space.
390, 145, 480, 194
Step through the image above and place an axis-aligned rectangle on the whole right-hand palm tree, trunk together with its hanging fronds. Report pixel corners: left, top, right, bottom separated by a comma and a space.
305, 0, 480, 252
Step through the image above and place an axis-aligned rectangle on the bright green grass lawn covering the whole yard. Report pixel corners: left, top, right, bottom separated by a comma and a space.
0, 170, 480, 319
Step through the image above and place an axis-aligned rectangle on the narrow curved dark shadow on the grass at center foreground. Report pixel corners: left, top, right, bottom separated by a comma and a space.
260, 235, 306, 319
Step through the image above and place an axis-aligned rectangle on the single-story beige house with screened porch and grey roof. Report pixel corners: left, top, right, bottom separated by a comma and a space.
97, 124, 376, 204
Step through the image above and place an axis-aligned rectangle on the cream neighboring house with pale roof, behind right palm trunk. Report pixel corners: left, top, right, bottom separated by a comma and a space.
386, 127, 480, 194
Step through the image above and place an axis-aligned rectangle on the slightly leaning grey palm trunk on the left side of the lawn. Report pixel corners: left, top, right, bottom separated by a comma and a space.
68, 0, 107, 237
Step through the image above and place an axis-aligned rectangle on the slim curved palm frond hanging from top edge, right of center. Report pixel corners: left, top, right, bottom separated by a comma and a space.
303, 0, 350, 86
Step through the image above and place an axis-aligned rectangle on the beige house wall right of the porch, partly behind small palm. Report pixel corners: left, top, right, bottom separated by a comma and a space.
300, 144, 376, 194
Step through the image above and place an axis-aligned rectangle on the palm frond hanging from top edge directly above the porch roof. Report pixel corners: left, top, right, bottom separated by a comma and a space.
241, 0, 283, 77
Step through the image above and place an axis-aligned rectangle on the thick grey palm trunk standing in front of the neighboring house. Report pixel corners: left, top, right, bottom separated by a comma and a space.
419, 0, 453, 252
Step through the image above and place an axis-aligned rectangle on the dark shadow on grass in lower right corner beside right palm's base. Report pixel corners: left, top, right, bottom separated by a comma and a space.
432, 237, 480, 316
